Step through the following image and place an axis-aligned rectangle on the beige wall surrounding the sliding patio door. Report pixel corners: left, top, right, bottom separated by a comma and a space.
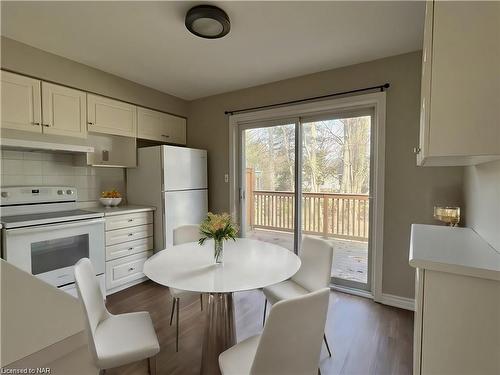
188, 52, 463, 297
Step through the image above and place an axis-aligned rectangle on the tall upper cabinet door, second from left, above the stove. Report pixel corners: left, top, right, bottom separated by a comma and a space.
42, 82, 87, 138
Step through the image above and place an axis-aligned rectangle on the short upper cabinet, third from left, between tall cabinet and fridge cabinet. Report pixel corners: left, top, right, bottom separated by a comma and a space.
87, 94, 137, 137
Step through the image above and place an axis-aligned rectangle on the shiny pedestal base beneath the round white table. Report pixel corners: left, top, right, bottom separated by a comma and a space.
201, 293, 236, 375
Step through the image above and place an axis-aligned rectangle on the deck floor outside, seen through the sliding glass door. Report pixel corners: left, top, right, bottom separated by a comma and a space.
248, 229, 368, 284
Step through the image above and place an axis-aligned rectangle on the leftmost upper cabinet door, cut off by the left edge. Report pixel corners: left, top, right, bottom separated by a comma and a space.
1, 71, 42, 133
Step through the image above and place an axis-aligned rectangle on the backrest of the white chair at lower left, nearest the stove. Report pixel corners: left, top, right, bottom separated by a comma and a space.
75, 258, 110, 362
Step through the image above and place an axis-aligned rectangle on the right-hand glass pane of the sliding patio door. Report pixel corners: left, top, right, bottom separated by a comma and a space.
301, 111, 372, 290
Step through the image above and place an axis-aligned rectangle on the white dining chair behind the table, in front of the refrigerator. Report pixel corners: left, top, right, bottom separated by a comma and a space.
169, 225, 203, 352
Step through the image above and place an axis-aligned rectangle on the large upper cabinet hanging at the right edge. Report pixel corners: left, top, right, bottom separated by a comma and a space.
416, 1, 500, 166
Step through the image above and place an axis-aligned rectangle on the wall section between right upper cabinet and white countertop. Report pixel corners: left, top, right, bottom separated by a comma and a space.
464, 161, 500, 252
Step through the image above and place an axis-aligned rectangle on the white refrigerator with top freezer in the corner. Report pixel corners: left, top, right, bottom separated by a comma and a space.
127, 146, 208, 251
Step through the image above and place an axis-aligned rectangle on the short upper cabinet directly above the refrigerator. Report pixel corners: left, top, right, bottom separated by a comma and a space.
137, 107, 186, 145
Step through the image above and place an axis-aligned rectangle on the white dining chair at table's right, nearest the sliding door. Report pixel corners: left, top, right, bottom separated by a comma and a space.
262, 237, 333, 357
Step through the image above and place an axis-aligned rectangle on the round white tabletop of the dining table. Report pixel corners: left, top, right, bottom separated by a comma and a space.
144, 238, 300, 293
